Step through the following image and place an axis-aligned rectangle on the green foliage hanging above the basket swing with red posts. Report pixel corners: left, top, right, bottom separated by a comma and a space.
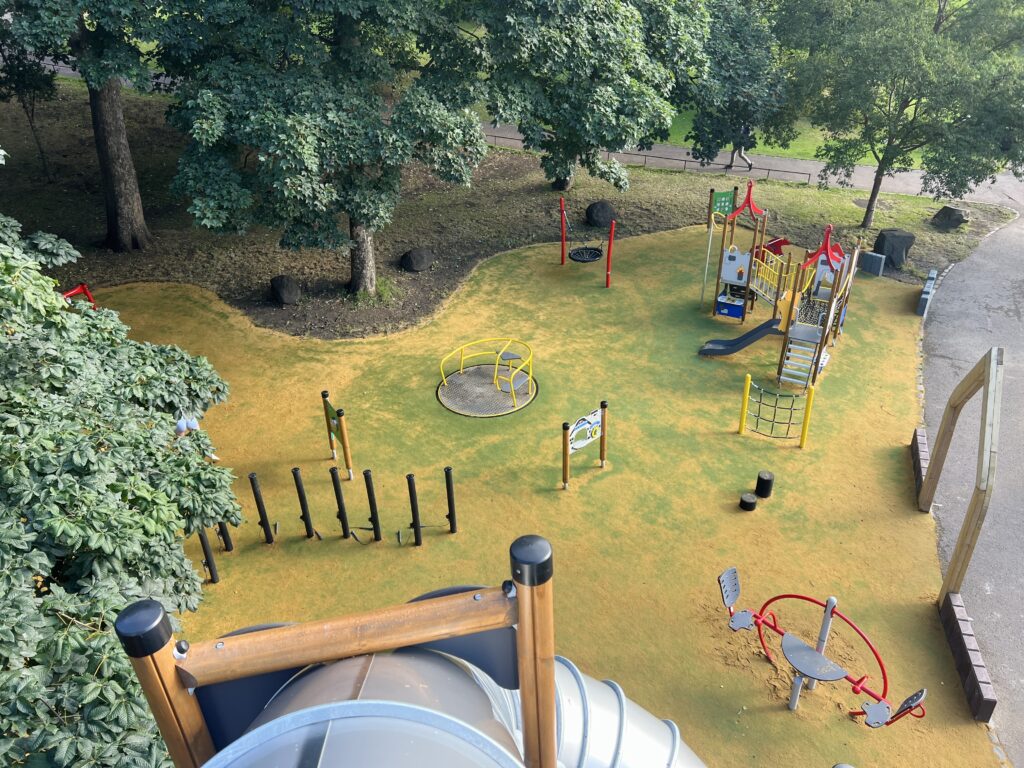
474, 0, 708, 189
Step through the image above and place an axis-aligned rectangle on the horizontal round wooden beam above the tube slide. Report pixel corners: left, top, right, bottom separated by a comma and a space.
178, 587, 518, 688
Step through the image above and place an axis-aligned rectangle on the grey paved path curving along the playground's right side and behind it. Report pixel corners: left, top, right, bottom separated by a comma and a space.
485, 120, 1024, 768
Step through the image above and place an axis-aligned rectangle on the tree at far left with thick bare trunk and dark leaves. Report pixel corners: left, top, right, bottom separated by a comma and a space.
8, 0, 158, 251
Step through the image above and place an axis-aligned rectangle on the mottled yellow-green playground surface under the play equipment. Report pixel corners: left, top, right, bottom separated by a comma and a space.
97, 227, 997, 768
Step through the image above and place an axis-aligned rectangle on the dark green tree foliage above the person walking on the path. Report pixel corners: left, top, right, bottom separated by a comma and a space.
681, 0, 796, 162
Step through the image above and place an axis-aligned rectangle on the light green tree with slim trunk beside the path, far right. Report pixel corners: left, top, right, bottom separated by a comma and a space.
776, 0, 1024, 227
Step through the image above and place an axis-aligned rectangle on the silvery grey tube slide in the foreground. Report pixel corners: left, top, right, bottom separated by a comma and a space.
206, 649, 705, 768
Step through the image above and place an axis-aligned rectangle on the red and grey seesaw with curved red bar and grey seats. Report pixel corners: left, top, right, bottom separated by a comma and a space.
718, 568, 928, 728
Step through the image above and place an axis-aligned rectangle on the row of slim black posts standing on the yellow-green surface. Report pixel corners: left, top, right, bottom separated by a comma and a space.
199, 467, 459, 584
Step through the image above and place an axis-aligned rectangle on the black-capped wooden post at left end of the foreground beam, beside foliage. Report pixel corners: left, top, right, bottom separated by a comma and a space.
114, 600, 214, 768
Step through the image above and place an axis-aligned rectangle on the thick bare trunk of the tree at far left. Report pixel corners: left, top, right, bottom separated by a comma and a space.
89, 78, 150, 251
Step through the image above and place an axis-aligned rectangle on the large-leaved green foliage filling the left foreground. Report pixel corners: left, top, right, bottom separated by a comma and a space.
0, 217, 241, 766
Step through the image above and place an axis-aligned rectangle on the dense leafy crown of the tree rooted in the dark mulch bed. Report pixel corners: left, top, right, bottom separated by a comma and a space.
163, 0, 485, 248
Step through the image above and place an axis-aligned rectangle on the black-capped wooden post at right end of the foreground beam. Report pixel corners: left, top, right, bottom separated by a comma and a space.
509, 536, 558, 768
